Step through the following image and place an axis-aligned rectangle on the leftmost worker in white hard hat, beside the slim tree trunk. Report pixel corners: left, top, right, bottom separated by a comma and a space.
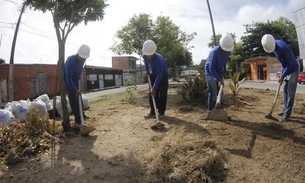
64, 45, 90, 126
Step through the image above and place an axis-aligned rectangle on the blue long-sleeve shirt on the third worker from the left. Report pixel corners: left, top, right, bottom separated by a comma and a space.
205, 46, 230, 82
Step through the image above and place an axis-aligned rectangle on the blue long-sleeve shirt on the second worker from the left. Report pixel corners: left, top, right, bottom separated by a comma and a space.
142, 53, 168, 90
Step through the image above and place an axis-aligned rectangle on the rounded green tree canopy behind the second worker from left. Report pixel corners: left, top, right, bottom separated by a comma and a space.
110, 14, 197, 70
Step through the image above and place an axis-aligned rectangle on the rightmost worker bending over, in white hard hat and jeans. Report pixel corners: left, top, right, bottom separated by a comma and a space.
261, 34, 300, 122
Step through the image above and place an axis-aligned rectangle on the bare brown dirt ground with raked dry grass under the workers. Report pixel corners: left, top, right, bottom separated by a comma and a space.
0, 83, 305, 183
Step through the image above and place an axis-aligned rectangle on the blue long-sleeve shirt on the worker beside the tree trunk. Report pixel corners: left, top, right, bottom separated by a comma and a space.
64, 54, 85, 93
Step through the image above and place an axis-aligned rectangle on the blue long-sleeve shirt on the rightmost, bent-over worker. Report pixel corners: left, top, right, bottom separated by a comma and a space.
274, 39, 299, 79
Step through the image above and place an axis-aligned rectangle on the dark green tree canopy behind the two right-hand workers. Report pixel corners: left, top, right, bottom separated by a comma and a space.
202, 17, 299, 77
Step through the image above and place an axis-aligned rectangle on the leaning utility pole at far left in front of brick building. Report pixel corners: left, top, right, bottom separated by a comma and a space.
8, 3, 25, 101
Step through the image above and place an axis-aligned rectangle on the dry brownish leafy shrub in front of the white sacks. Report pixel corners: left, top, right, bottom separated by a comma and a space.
0, 109, 57, 170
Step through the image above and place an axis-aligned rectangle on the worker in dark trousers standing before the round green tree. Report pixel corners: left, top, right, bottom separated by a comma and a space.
142, 40, 168, 118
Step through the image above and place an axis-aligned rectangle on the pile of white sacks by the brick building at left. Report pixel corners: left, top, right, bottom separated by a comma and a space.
0, 94, 89, 125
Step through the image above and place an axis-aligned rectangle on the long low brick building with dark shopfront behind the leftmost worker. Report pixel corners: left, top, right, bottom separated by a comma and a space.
0, 64, 123, 103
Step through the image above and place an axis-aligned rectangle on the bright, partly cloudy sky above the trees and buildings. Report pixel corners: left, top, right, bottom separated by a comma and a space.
0, 0, 305, 67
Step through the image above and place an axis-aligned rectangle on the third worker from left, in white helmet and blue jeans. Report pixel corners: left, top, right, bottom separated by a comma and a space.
204, 35, 234, 113
